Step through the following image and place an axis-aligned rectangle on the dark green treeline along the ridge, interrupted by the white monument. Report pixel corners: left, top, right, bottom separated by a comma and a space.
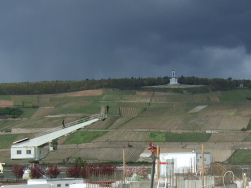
0, 76, 251, 95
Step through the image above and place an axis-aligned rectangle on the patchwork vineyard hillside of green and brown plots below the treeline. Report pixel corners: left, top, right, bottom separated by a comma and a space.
0, 88, 251, 163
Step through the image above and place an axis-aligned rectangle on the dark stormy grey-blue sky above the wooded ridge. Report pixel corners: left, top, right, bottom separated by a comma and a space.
0, 0, 251, 83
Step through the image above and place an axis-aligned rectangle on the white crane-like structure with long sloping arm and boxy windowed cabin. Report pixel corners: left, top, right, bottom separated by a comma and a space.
11, 113, 107, 162
